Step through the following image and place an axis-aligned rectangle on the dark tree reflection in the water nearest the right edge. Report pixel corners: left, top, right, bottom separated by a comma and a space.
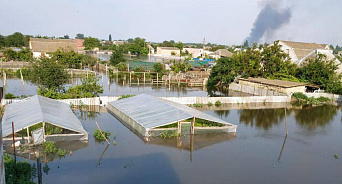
294, 105, 339, 130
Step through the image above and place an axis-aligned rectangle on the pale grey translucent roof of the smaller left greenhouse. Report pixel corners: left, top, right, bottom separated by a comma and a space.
2, 95, 87, 137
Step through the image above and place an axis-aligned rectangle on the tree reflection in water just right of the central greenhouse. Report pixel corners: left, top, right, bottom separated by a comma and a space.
239, 109, 291, 130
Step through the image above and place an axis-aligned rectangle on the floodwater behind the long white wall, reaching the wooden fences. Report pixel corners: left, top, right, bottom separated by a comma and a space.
0, 73, 244, 97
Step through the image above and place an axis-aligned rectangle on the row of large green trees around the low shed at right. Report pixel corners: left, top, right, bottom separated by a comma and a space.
208, 41, 342, 94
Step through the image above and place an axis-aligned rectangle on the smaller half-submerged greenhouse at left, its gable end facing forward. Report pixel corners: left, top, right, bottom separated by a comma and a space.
2, 95, 88, 144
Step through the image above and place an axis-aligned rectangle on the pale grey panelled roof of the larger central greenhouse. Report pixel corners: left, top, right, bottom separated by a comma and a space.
110, 94, 235, 129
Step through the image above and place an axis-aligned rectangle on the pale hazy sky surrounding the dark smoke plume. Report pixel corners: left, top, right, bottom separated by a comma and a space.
0, 0, 342, 45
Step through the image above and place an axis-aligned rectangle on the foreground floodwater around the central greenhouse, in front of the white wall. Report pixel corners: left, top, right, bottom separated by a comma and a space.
12, 105, 342, 184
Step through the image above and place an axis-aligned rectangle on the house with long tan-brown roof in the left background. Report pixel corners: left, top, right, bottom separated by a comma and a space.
29, 38, 78, 58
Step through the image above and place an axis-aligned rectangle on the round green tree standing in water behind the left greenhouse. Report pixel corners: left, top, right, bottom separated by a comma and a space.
29, 58, 70, 91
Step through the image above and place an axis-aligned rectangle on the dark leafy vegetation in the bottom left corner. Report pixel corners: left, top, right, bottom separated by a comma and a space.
4, 154, 37, 184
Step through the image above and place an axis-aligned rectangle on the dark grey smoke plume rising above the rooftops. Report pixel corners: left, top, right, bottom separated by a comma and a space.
246, 2, 292, 44
